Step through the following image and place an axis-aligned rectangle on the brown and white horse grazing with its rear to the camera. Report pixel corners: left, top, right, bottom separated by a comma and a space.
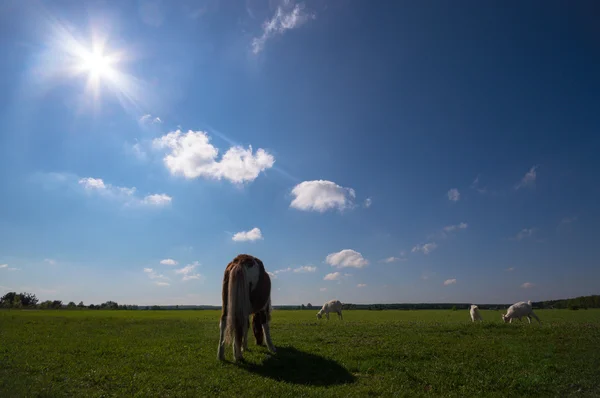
217, 254, 276, 362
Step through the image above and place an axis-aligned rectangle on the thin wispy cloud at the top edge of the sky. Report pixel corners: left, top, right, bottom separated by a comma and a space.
252, 1, 316, 54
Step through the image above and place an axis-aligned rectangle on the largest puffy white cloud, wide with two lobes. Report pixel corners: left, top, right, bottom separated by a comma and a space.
152, 130, 275, 184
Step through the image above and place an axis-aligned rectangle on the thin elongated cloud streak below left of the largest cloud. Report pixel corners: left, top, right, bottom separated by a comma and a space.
78, 177, 172, 207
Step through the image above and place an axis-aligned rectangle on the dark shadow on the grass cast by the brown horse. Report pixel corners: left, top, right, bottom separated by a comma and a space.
244, 347, 355, 386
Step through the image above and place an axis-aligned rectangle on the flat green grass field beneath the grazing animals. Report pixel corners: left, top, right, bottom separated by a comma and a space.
0, 310, 600, 398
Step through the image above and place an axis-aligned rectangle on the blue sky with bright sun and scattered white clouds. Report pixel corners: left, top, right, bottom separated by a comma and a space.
0, 0, 600, 305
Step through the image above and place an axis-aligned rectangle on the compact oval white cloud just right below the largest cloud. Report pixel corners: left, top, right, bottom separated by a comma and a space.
290, 180, 356, 213
